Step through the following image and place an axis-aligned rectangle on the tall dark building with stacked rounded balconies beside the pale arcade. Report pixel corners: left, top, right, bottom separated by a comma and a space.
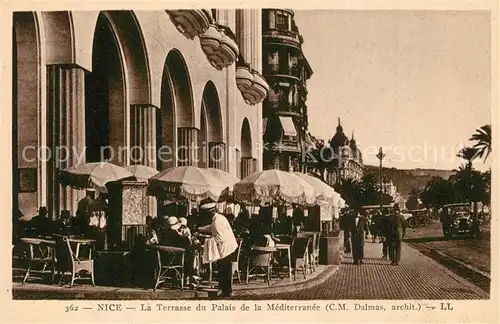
262, 9, 312, 171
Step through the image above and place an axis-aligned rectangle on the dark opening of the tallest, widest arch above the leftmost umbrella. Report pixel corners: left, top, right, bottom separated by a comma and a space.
85, 13, 122, 162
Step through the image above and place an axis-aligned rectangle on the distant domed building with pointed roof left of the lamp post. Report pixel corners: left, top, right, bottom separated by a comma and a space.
326, 118, 363, 186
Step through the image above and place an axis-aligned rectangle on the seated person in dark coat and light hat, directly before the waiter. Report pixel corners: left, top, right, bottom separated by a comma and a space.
159, 216, 196, 287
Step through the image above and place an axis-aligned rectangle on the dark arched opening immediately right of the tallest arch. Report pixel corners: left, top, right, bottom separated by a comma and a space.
157, 49, 196, 170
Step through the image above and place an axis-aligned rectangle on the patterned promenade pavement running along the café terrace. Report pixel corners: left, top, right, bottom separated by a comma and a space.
13, 233, 489, 300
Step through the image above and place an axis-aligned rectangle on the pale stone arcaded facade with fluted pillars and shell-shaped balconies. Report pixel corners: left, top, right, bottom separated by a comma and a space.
12, 9, 268, 218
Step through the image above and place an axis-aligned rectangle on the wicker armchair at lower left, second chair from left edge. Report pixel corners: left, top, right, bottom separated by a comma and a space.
56, 236, 95, 287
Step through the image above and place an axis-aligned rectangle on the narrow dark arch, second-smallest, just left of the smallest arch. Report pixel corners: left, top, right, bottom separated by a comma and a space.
202, 81, 224, 143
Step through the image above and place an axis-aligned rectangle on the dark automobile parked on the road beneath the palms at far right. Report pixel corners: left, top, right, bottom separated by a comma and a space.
441, 203, 479, 238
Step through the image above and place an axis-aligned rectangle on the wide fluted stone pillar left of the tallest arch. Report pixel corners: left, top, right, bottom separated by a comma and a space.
47, 65, 85, 218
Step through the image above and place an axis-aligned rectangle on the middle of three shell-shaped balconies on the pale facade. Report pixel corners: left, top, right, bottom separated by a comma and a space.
199, 24, 239, 70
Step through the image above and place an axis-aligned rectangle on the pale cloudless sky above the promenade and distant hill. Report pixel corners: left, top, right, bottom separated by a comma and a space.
295, 10, 492, 170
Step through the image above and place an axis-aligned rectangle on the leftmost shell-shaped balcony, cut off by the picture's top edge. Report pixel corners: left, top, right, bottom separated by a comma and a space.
166, 9, 213, 39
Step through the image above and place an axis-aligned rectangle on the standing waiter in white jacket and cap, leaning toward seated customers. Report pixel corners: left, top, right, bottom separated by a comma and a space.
198, 203, 238, 297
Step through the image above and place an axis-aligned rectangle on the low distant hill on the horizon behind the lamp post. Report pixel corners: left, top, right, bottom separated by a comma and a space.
365, 165, 453, 198
